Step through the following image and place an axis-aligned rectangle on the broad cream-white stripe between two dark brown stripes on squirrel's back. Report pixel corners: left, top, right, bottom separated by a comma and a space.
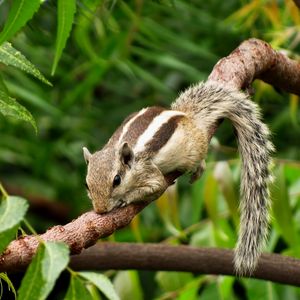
134, 110, 185, 153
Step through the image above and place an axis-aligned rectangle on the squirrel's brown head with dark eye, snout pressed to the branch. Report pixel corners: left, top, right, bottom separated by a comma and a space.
83, 142, 167, 213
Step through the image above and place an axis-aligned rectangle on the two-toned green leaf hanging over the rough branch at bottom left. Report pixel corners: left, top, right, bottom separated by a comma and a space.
18, 242, 69, 300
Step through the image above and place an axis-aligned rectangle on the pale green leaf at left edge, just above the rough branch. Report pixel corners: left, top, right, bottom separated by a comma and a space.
0, 196, 28, 252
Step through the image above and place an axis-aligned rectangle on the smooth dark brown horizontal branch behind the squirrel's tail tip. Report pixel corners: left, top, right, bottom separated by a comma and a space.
70, 242, 300, 286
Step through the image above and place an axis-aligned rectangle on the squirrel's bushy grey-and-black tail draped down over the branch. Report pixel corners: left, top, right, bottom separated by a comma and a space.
172, 82, 273, 275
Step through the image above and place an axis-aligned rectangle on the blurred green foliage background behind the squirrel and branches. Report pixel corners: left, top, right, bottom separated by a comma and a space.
0, 0, 300, 299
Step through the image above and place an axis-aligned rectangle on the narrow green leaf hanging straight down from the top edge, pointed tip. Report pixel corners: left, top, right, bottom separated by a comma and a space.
51, 0, 76, 75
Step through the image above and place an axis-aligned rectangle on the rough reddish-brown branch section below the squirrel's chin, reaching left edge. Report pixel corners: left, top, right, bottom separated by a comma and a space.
0, 203, 147, 272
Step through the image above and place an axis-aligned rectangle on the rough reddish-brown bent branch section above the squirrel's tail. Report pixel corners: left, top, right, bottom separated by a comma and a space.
208, 39, 300, 95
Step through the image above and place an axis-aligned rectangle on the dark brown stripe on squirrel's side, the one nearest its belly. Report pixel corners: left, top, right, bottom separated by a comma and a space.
145, 115, 184, 153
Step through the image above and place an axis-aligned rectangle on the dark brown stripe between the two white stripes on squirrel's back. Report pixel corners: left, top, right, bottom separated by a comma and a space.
123, 106, 165, 147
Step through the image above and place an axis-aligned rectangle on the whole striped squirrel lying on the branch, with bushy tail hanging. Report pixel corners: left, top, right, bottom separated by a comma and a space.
83, 81, 273, 275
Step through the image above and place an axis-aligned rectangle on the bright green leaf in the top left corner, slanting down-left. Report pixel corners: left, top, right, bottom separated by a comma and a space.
0, 0, 41, 45
